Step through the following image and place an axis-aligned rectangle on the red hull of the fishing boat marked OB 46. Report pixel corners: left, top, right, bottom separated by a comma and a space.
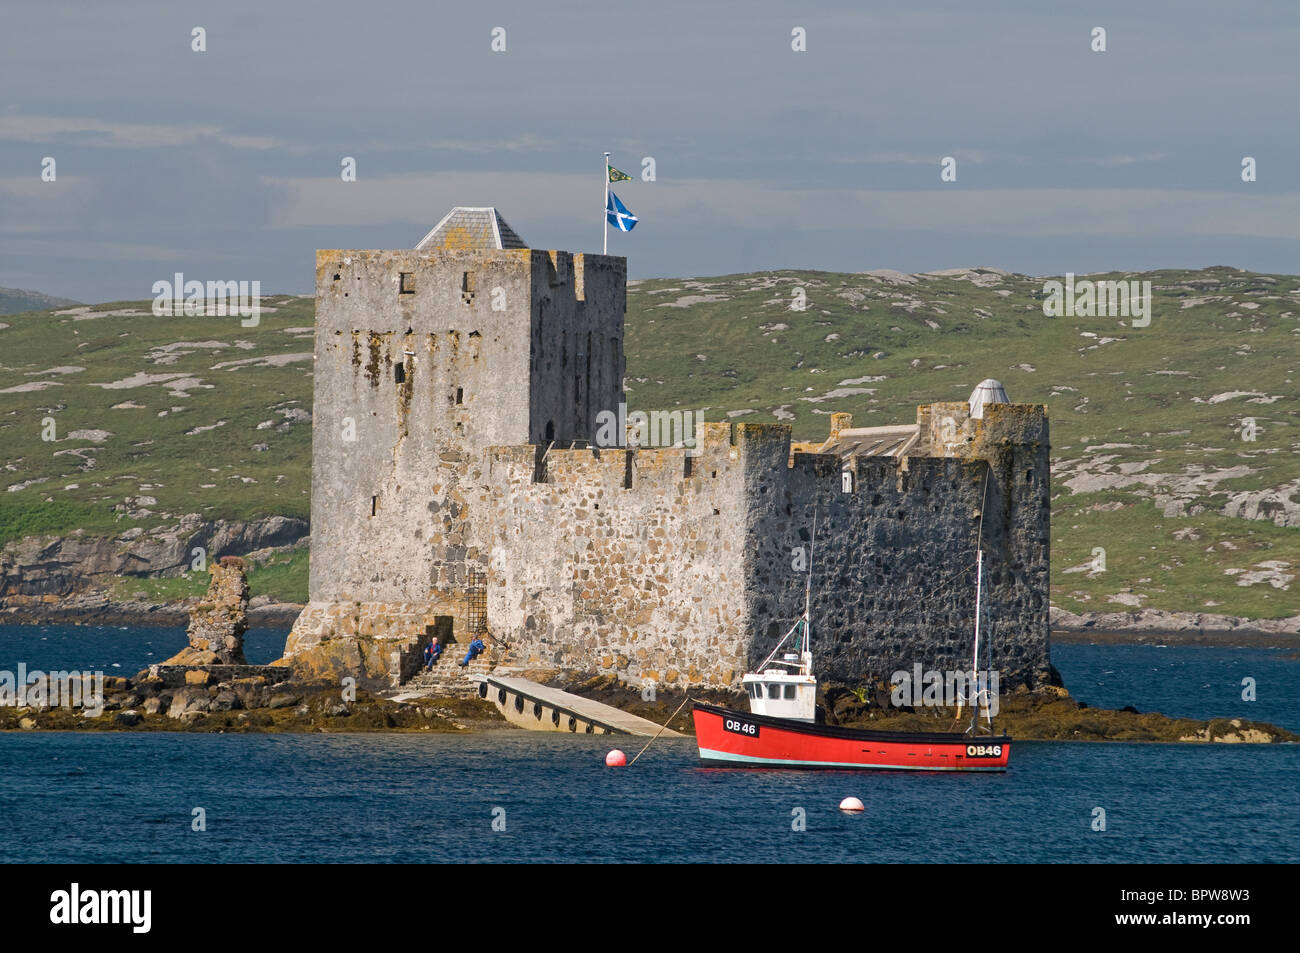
692, 702, 1011, 771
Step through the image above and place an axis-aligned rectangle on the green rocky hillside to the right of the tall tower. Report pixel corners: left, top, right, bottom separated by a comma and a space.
628, 268, 1300, 618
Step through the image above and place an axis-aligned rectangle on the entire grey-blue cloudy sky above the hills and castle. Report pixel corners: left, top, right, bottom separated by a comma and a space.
0, 0, 1300, 302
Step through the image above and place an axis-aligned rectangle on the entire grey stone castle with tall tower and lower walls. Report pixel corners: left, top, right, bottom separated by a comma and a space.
285, 208, 1052, 686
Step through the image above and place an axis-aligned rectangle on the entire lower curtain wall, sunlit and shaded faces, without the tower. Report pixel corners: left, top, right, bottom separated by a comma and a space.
489, 406, 1050, 688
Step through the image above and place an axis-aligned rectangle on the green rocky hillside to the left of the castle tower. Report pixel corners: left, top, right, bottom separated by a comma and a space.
0, 298, 313, 530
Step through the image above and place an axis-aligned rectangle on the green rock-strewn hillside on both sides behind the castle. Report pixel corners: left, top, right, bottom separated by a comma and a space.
0, 268, 1300, 618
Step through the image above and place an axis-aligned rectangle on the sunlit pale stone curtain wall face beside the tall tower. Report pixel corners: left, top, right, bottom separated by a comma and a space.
488, 424, 750, 685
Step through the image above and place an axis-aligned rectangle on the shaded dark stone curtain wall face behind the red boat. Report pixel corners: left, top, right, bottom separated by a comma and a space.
749, 403, 1050, 688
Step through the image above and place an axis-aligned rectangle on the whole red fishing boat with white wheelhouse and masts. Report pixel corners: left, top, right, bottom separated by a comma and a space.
692, 524, 1011, 771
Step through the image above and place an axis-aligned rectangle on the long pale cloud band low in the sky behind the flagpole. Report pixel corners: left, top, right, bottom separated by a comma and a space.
267, 172, 1300, 243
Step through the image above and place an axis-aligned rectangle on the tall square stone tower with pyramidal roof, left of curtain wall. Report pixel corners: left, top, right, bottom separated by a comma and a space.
285, 208, 627, 679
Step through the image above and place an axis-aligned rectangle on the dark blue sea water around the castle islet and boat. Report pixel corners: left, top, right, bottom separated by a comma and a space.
0, 627, 1300, 863
